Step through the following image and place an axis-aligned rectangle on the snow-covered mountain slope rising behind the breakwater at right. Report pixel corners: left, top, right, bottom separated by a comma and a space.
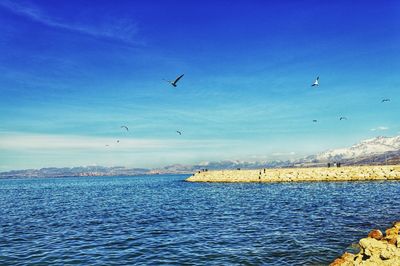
307, 136, 400, 162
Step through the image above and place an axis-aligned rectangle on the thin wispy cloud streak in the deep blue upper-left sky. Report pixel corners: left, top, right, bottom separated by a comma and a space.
0, 0, 141, 44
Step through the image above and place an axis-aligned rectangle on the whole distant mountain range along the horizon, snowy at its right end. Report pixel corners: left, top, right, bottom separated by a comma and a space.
0, 136, 400, 178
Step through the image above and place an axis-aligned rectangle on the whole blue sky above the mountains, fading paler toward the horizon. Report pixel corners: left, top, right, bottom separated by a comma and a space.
0, 0, 400, 170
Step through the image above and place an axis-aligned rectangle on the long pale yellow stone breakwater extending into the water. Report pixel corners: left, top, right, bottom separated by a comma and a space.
186, 165, 400, 183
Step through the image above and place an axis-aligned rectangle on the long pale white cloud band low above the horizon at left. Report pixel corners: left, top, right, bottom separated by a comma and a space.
0, 132, 247, 170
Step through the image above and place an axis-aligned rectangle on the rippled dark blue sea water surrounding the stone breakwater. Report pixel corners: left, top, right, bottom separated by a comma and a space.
0, 175, 400, 265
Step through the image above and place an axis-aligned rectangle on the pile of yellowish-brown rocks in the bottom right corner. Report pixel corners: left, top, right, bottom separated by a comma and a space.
330, 221, 400, 266
